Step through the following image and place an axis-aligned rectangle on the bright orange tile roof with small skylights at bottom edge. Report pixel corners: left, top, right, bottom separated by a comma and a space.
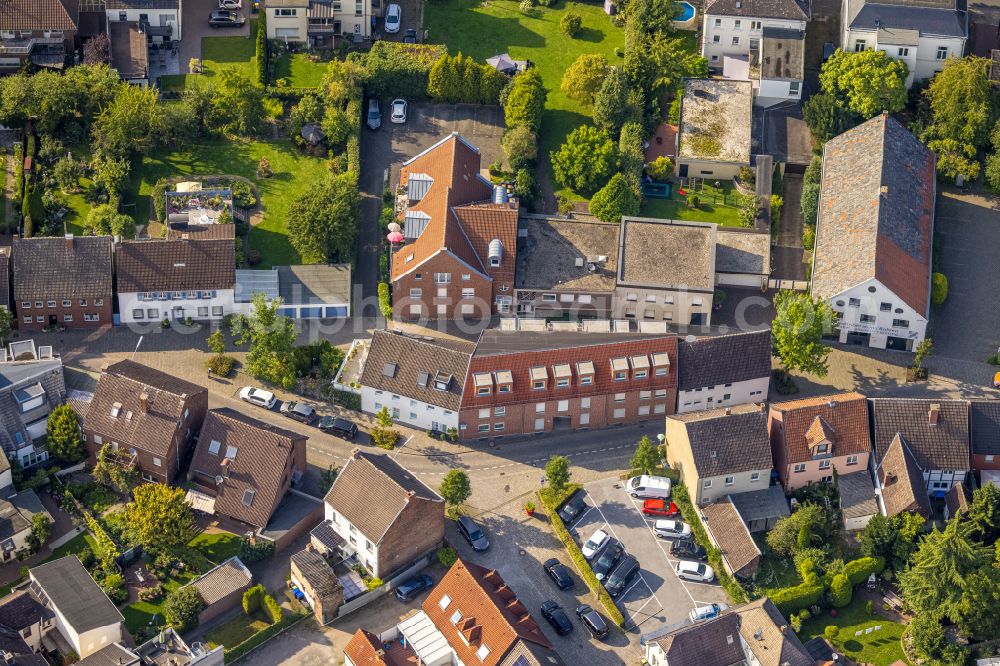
423, 560, 552, 666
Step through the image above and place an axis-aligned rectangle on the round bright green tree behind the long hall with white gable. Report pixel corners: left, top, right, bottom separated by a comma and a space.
819, 49, 909, 119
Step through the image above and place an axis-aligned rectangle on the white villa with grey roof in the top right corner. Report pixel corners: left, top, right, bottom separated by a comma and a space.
840, 0, 969, 87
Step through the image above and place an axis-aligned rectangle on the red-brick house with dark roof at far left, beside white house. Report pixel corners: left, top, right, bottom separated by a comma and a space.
13, 234, 113, 331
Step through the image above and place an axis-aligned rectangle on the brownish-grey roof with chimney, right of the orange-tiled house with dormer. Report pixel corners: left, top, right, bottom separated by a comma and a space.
871, 398, 969, 472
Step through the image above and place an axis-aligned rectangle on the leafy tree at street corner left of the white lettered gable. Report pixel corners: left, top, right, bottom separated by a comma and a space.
771, 291, 836, 377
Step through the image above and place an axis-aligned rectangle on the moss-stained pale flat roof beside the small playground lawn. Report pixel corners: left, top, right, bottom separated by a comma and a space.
678, 79, 753, 164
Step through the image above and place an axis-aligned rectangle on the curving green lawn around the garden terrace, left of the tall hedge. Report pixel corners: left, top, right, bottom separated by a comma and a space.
127, 139, 326, 268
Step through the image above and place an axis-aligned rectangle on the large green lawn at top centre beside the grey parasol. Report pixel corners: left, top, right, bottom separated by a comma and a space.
424, 0, 624, 199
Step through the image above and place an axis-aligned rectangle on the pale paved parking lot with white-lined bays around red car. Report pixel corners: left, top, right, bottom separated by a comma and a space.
570, 479, 728, 634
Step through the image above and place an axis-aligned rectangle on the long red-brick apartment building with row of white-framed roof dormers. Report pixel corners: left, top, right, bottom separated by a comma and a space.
459, 330, 677, 439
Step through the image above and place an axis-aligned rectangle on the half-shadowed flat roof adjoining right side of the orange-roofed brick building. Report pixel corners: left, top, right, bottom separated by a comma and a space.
517, 218, 619, 291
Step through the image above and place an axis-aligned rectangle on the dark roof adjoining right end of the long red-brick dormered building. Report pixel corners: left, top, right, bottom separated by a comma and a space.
677, 329, 771, 391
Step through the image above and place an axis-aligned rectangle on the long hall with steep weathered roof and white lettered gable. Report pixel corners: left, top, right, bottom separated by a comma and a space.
811, 114, 937, 351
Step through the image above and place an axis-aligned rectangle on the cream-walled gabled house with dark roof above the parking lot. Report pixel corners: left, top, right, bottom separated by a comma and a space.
664, 405, 772, 506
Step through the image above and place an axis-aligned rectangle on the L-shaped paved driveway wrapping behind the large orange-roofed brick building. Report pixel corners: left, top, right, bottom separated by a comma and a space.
356, 101, 503, 306
